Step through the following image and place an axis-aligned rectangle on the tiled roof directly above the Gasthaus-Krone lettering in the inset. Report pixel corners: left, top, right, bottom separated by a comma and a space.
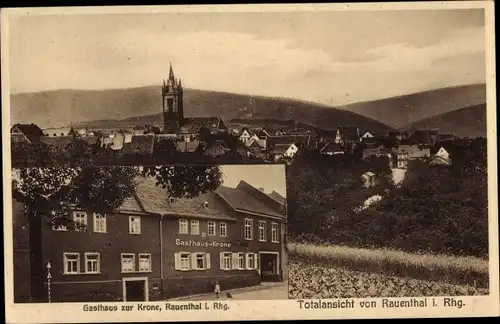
132, 177, 234, 220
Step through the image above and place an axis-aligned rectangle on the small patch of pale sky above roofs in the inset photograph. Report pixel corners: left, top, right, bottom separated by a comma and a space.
220, 164, 286, 197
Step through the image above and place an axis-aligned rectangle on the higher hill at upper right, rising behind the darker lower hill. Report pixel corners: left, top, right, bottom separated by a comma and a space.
338, 84, 486, 128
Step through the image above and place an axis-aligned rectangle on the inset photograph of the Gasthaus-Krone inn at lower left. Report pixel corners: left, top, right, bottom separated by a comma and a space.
12, 165, 288, 305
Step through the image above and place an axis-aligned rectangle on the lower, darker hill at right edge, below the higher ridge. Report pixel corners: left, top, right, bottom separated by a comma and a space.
403, 104, 487, 137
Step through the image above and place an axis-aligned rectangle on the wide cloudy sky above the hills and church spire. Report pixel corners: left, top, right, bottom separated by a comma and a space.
6, 10, 485, 105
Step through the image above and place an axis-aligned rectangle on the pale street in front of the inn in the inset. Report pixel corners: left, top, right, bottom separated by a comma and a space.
170, 282, 288, 301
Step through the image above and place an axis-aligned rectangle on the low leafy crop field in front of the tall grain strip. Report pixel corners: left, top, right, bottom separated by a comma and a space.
288, 258, 488, 299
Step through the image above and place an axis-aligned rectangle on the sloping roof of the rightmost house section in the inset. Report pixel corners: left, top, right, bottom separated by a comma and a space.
217, 180, 283, 217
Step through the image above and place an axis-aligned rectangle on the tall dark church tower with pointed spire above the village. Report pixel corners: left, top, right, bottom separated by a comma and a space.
161, 64, 184, 133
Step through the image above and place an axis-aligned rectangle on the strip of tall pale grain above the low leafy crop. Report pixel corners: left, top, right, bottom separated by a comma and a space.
287, 243, 489, 288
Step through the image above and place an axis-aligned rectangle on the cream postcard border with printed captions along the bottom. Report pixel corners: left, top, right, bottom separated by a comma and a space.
1, 1, 500, 323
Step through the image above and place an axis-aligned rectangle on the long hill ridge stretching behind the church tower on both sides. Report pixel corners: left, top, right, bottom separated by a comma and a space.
11, 86, 392, 132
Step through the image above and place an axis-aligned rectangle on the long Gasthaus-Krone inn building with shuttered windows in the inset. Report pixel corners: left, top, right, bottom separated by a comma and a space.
13, 177, 286, 302
